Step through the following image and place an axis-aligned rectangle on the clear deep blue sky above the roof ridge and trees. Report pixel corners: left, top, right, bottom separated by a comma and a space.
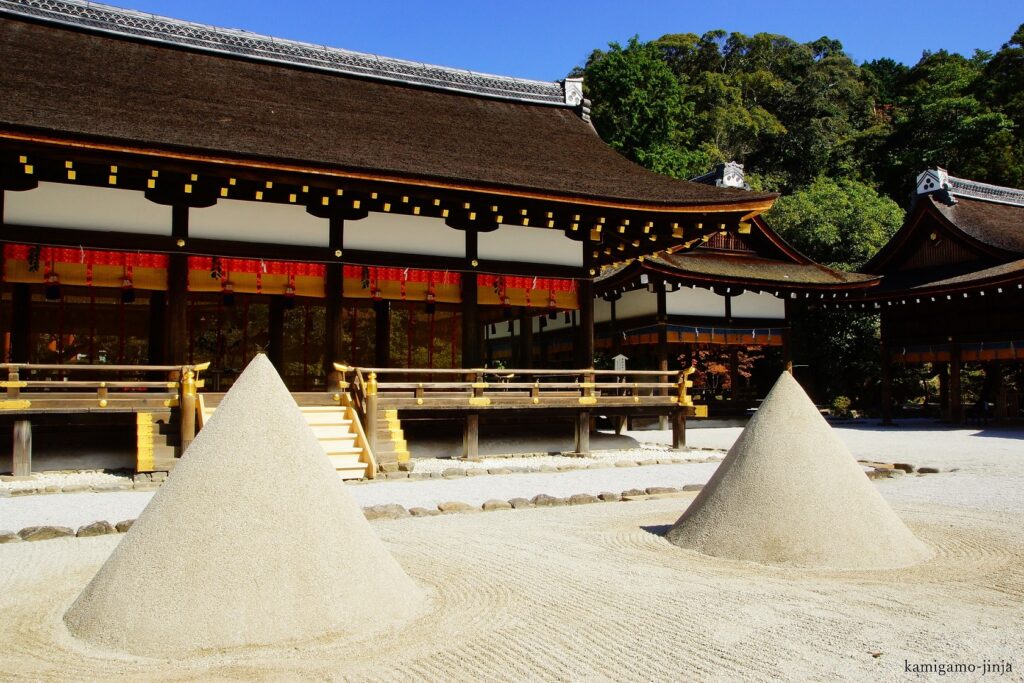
106, 0, 1024, 81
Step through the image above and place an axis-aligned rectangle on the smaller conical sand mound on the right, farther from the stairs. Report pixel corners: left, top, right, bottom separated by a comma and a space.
667, 373, 931, 569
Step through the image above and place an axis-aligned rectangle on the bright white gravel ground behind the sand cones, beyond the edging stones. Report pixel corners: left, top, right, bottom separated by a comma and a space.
0, 421, 1024, 531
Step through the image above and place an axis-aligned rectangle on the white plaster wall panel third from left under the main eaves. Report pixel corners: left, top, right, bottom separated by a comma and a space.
343, 213, 466, 257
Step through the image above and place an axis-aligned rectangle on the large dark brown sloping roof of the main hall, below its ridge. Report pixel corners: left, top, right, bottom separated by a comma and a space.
0, 7, 774, 208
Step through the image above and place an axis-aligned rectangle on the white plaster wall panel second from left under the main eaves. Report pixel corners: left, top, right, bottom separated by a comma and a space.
188, 200, 330, 247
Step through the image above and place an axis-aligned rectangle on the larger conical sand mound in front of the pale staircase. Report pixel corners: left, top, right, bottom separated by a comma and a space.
65, 355, 423, 656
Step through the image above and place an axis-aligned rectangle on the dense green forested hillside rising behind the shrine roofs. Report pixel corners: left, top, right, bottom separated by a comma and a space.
578, 25, 1024, 407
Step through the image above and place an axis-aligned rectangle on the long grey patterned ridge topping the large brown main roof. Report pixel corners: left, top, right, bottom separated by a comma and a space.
0, 0, 583, 106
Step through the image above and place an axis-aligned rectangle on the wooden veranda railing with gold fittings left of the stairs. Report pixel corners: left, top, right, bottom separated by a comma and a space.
0, 362, 210, 475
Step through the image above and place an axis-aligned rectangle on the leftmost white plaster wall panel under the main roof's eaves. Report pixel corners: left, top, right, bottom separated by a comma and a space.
3, 182, 171, 236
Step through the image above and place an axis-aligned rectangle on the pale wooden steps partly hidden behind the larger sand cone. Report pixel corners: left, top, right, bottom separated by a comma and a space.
197, 394, 377, 479
